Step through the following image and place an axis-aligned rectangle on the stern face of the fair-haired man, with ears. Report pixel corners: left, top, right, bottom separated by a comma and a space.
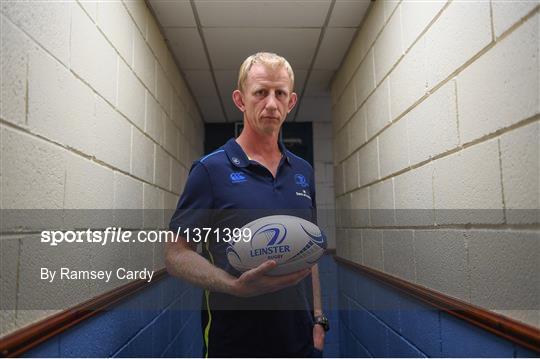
233, 64, 296, 134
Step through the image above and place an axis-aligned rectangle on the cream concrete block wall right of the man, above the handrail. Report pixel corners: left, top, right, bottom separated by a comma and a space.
331, 0, 540, 330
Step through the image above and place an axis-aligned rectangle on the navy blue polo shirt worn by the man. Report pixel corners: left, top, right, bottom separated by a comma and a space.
170, 138, 317, 357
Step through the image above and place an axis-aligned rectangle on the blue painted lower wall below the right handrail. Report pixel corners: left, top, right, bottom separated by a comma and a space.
338, 265, 538, 357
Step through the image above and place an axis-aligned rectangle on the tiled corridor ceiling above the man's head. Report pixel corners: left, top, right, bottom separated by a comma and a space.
147, 0, 370, 122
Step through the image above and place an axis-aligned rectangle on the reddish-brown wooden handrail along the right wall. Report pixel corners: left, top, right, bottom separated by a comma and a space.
334, 255, 540, 352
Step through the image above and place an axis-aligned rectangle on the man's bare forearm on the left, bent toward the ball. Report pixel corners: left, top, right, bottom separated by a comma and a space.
166, 243, 234, 293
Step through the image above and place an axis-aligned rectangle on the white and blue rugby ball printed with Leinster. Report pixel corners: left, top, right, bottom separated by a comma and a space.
227, 215, 327, 275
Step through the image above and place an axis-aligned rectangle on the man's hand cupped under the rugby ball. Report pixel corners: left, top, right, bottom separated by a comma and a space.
230, 260, 311, 297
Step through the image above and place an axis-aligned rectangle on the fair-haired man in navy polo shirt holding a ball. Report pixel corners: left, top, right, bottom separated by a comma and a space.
166, 53, 327, 357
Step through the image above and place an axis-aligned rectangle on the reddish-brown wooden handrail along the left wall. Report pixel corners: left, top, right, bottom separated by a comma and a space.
0, 269, 167, 357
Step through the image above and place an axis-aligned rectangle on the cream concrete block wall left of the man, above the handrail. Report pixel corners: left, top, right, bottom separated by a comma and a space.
0, 0, 204, 338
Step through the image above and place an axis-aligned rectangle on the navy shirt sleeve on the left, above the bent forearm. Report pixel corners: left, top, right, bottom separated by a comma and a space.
169, 162, 214, 232
